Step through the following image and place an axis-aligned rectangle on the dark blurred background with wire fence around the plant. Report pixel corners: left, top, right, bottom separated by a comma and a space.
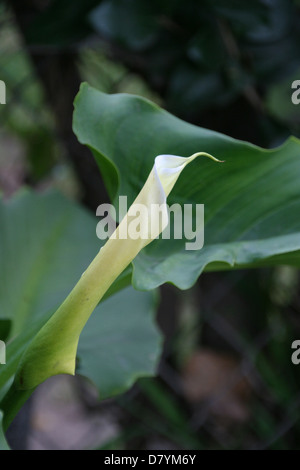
0, 0, 300, 449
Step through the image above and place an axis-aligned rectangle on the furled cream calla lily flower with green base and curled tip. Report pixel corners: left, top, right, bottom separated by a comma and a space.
14, 152, 219, 390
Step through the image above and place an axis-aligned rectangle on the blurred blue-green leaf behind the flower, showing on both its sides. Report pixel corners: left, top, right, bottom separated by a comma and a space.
0, 190, 160, 411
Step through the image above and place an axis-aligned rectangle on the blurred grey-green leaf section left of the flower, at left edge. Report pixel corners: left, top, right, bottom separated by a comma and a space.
0, 191, 101, 336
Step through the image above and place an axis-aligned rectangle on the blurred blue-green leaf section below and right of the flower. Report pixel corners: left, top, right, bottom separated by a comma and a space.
78, 287, 161, 399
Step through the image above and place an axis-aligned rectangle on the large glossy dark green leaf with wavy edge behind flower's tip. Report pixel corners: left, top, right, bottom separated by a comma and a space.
74, 84, 300, 289
